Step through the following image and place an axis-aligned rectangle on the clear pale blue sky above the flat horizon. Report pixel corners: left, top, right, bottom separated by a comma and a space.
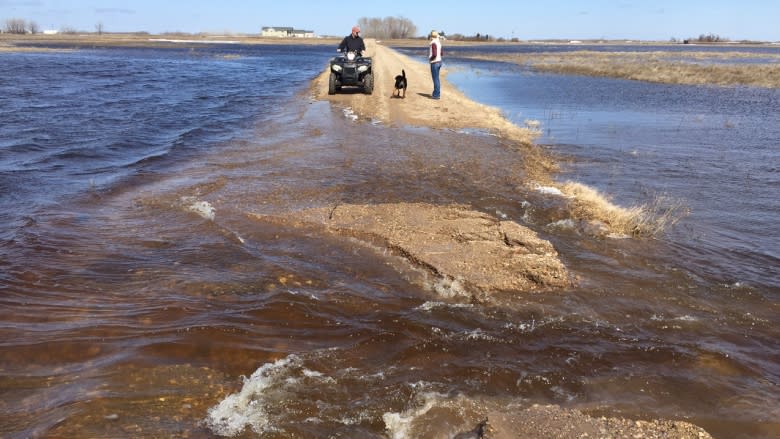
0, 0, 780, 41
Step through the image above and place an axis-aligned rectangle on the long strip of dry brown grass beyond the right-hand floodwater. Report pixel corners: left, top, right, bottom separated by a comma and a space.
464, 51, 780, 88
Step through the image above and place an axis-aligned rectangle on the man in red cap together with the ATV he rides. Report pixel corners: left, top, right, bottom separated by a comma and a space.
328, 26, 374, 95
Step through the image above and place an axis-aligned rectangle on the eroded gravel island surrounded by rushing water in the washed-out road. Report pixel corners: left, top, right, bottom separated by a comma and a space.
254, 203, 569, 298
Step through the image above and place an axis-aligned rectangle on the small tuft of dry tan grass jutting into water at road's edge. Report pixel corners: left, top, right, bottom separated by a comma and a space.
560, 181, 688, 237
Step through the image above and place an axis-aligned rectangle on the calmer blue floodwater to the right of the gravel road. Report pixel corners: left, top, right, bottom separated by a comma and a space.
438, 49, 780, 287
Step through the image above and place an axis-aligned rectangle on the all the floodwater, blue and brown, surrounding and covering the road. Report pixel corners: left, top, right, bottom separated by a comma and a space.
0, 45, 780, 438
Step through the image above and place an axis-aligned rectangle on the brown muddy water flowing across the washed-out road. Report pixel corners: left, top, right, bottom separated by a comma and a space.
0, 45, 780, 438
